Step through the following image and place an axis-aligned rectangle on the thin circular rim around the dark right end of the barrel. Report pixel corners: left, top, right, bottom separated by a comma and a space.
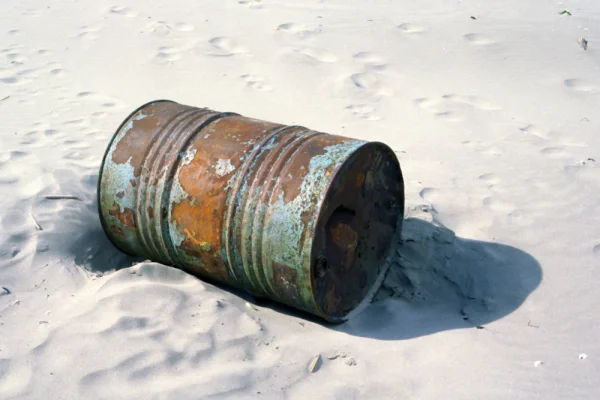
309, 139, 406, 324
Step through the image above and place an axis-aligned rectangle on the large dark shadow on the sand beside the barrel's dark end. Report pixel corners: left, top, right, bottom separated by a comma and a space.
332, 218, 542, 340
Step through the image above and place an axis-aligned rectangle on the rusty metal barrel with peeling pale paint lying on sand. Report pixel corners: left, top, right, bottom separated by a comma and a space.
98, 100, 404, 322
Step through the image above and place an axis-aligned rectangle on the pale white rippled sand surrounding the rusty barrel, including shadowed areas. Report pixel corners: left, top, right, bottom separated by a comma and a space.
0, 0, 600, 400
